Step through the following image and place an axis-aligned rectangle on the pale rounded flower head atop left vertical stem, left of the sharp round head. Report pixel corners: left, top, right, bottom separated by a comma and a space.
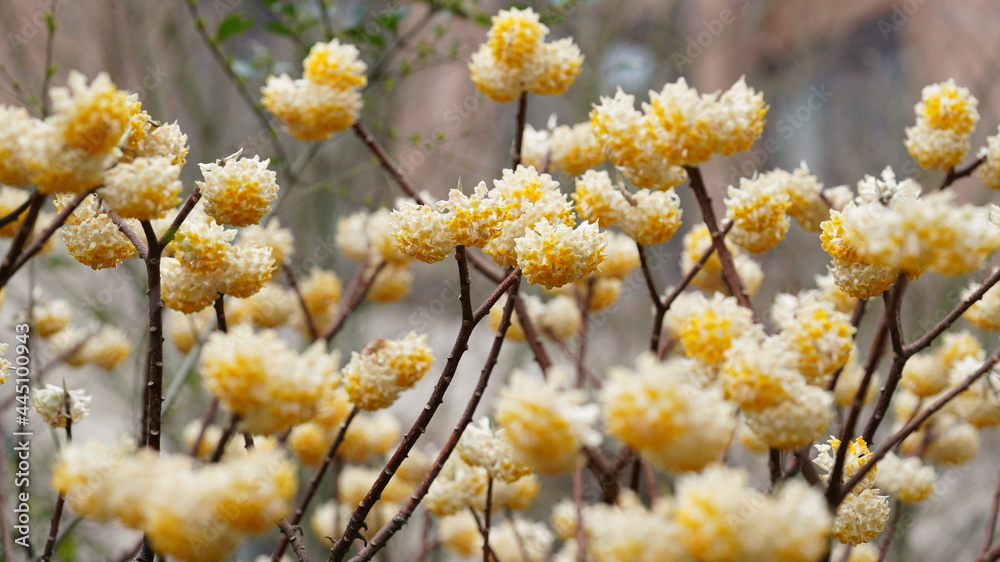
98, 156, 182, 220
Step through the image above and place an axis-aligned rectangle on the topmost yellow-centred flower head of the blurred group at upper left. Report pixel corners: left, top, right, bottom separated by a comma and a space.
50, 70, 140, 156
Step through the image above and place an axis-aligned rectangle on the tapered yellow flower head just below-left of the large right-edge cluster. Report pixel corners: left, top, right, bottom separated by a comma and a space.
774, 294, 856, 386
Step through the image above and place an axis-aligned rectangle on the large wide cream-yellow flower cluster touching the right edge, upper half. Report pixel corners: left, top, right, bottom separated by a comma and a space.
821, 168, 1000, 280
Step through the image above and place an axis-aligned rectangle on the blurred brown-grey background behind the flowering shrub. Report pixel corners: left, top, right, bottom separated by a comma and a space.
0, 0, 1000, 561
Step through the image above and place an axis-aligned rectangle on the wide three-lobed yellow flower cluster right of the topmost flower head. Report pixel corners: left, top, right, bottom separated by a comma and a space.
590, 78, 767, 189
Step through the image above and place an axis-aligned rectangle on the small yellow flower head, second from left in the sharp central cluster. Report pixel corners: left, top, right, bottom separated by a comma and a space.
437, 182, 504, 248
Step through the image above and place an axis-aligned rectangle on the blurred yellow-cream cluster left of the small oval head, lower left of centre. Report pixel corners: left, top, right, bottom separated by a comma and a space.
199, 326, 338, 435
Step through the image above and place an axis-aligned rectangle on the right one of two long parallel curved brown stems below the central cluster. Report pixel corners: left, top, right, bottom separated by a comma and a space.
351, 262, 521, 562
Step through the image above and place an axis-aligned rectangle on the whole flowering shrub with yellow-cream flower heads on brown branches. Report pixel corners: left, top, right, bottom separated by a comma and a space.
0, 2, 1000, 562
